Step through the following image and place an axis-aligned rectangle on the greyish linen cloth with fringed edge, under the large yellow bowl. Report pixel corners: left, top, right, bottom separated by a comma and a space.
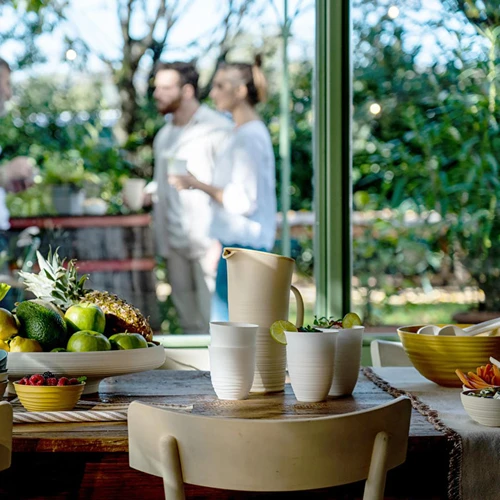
365, 367, 500, 500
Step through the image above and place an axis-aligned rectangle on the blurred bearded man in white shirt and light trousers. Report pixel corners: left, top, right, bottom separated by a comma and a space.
153, 62, 232, 333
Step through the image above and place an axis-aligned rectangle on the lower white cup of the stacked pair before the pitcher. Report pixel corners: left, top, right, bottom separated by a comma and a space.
208, 344, 255, 400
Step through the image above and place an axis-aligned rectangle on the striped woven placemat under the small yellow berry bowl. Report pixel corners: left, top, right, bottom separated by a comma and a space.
10, 398, 193, 424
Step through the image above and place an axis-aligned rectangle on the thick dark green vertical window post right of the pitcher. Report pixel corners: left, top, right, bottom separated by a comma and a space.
314, 0, 352, 317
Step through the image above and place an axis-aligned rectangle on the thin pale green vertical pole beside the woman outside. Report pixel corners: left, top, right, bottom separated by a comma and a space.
280, 0, 291, 257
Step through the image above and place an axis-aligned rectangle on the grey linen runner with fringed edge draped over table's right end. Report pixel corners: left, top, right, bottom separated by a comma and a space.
363, 367, 500, 500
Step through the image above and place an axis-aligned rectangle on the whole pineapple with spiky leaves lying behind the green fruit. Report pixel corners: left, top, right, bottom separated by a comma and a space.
19, 249, 153, 342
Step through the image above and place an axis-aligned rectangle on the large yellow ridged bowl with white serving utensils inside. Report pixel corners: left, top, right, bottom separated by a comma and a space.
398, 325, 500, 387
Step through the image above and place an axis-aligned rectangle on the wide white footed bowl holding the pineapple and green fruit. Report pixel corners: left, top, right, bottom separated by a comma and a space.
7, 346, 165, 394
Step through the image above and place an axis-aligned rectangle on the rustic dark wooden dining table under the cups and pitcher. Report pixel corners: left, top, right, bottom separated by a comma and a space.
0, 370, 448, 500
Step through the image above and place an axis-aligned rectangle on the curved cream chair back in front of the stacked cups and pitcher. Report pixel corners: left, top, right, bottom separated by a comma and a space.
128, 397, 411, 500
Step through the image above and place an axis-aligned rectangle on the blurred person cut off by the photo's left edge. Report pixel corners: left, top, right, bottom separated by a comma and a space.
0, 58, 35, 231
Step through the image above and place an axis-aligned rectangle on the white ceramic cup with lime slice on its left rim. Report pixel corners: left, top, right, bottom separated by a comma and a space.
285, 331, 337, 403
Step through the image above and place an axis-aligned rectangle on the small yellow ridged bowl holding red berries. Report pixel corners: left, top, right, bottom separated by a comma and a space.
14, 382, 85, 411
